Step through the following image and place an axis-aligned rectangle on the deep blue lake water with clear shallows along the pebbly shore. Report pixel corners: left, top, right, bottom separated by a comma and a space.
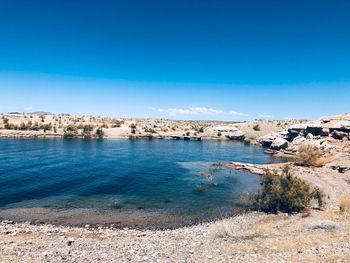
0, 139, 274, 228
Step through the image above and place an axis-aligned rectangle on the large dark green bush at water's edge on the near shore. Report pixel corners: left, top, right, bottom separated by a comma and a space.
255, 166, 324, 213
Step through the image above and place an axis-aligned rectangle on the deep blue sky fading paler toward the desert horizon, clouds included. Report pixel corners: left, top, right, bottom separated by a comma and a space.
0, 0, 350, 120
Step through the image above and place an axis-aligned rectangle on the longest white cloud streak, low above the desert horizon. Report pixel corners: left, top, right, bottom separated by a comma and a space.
151, 107, 250, 117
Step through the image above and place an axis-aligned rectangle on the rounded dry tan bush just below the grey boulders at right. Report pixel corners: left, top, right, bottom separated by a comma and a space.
297, 143, 323, 167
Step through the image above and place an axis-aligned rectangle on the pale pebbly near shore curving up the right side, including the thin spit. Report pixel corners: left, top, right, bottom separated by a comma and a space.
0, 113, 350, 263
